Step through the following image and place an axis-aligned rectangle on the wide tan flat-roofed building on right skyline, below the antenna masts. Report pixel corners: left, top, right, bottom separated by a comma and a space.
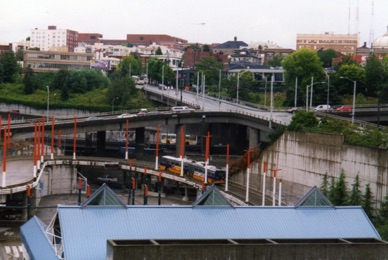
296, 32, 358, 56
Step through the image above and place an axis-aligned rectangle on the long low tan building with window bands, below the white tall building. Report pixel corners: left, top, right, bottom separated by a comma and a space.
23, 50, 93, 72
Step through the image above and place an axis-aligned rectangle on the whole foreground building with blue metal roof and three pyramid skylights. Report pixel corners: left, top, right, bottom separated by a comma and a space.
20, 184, 388, 260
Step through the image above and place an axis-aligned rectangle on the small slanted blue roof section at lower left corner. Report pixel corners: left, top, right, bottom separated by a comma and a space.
20, 217, 58, 260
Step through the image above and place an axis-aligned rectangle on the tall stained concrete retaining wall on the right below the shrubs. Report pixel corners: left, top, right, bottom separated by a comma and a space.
232, 132, 388, 205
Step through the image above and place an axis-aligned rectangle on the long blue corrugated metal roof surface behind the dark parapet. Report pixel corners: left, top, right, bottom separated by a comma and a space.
58, 206, 380, 259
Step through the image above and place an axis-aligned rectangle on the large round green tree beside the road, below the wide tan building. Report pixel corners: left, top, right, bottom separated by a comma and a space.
282, 49, 324, 106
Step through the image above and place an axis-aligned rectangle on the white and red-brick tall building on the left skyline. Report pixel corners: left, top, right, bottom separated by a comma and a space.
30, 25, 78, 52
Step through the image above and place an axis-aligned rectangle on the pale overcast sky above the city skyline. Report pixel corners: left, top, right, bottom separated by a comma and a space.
0, 0, 388, 49
